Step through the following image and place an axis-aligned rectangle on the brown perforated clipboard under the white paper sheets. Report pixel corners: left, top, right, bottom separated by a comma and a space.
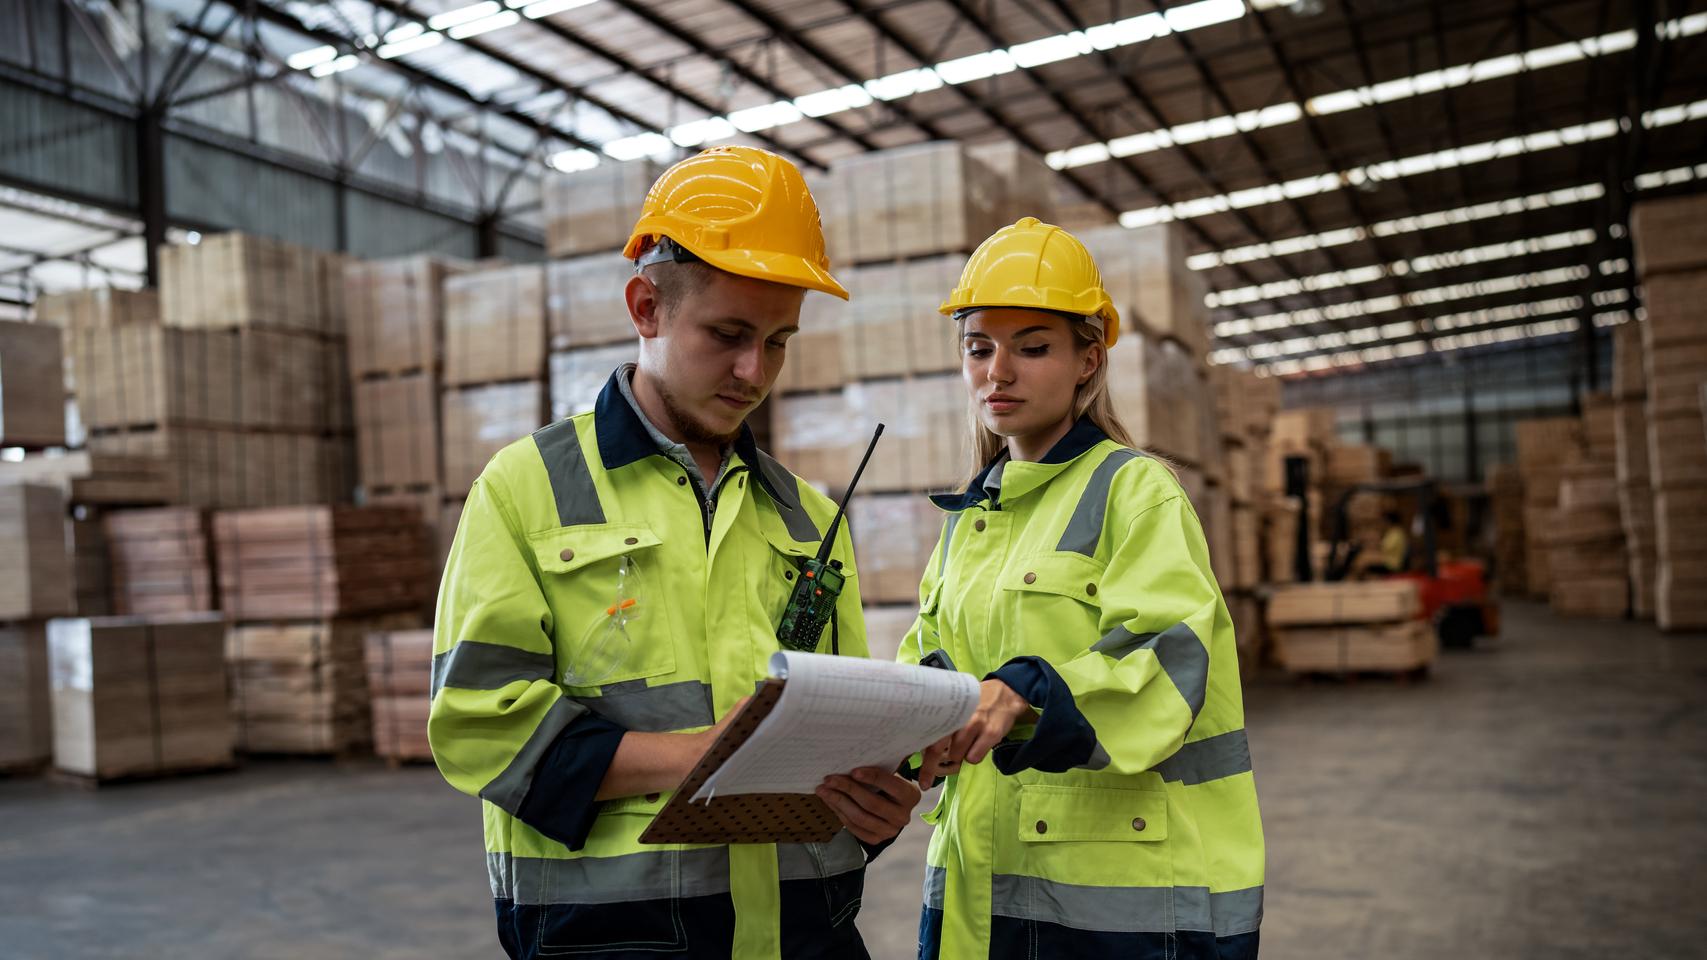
640, 678, 842, 844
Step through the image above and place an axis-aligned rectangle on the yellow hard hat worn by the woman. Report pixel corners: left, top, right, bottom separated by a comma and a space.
939, 217, 1120, 347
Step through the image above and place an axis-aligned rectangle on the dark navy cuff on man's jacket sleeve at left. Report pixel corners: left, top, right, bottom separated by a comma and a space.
516, 714, 628, 851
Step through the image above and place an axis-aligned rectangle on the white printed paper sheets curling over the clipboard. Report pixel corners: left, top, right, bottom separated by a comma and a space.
693, 651, 978, 801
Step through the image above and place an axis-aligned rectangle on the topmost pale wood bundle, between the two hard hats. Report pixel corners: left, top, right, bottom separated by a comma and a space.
816, 142, 1009, 263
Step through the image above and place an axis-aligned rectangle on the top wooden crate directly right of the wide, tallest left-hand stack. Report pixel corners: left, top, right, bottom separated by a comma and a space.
343, 256, 469, 378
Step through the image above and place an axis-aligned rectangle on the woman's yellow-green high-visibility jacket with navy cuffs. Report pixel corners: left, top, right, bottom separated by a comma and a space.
900, 420, 1263, 960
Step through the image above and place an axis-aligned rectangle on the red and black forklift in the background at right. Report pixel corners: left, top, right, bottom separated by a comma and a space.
1285, 456, 1499, 649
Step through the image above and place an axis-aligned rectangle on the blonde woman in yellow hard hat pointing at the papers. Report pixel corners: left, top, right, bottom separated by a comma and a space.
900, 217, 1263, 958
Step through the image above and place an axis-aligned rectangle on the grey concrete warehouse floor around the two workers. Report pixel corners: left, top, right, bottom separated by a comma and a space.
0, 605, 1707, 960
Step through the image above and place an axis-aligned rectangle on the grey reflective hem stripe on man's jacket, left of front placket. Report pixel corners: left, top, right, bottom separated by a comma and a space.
486, 847, 729, 905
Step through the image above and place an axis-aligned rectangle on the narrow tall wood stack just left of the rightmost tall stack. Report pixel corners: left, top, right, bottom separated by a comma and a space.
1611, 323, 1659, 620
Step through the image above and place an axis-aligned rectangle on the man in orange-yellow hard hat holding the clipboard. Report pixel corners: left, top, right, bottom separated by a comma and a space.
428, 147, 918, 958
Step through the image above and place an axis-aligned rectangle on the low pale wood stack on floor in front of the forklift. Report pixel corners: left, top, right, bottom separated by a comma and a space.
1268, 581, 1439, 673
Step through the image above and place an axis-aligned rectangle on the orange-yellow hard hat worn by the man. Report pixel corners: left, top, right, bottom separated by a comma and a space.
623, 145, 848, 301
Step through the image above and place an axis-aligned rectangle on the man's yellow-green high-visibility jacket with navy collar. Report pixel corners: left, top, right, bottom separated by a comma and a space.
428, 371, 867, 958
